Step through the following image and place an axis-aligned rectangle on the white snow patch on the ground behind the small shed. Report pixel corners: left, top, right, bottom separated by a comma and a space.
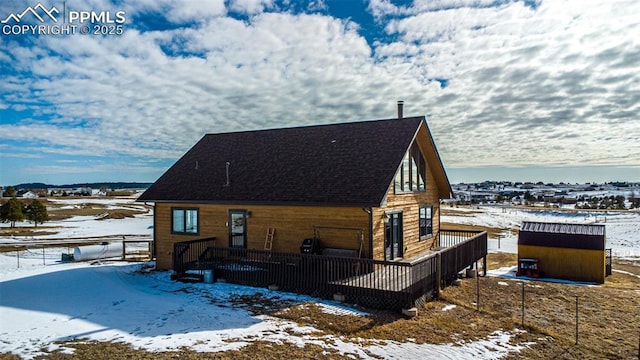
441, 206, 640, 257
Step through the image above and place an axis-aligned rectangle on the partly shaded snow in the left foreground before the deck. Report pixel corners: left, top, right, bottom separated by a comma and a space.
0, 255, 520, 359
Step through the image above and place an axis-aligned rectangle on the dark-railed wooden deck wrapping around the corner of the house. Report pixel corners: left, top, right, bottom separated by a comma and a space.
174, 233, 486, 309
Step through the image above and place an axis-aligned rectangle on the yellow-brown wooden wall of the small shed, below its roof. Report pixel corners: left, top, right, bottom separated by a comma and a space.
518, 245, 606, 284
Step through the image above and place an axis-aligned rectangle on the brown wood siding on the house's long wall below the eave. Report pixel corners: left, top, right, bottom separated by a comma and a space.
154, 203, 370, 269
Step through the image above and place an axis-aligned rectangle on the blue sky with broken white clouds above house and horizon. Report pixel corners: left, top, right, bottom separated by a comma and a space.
0, 0, 640, 185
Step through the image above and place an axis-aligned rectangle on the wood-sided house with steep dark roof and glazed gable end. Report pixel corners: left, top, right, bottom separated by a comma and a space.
138, 103, 452, 269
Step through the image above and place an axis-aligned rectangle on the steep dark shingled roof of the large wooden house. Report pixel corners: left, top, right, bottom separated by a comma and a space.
138, 117, 446, 206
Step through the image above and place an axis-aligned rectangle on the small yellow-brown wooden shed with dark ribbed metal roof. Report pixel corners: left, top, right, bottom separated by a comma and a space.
518, 221, 607, 283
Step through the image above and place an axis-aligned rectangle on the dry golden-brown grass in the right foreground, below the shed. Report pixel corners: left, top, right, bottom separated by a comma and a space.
442, 254, 640, 359
